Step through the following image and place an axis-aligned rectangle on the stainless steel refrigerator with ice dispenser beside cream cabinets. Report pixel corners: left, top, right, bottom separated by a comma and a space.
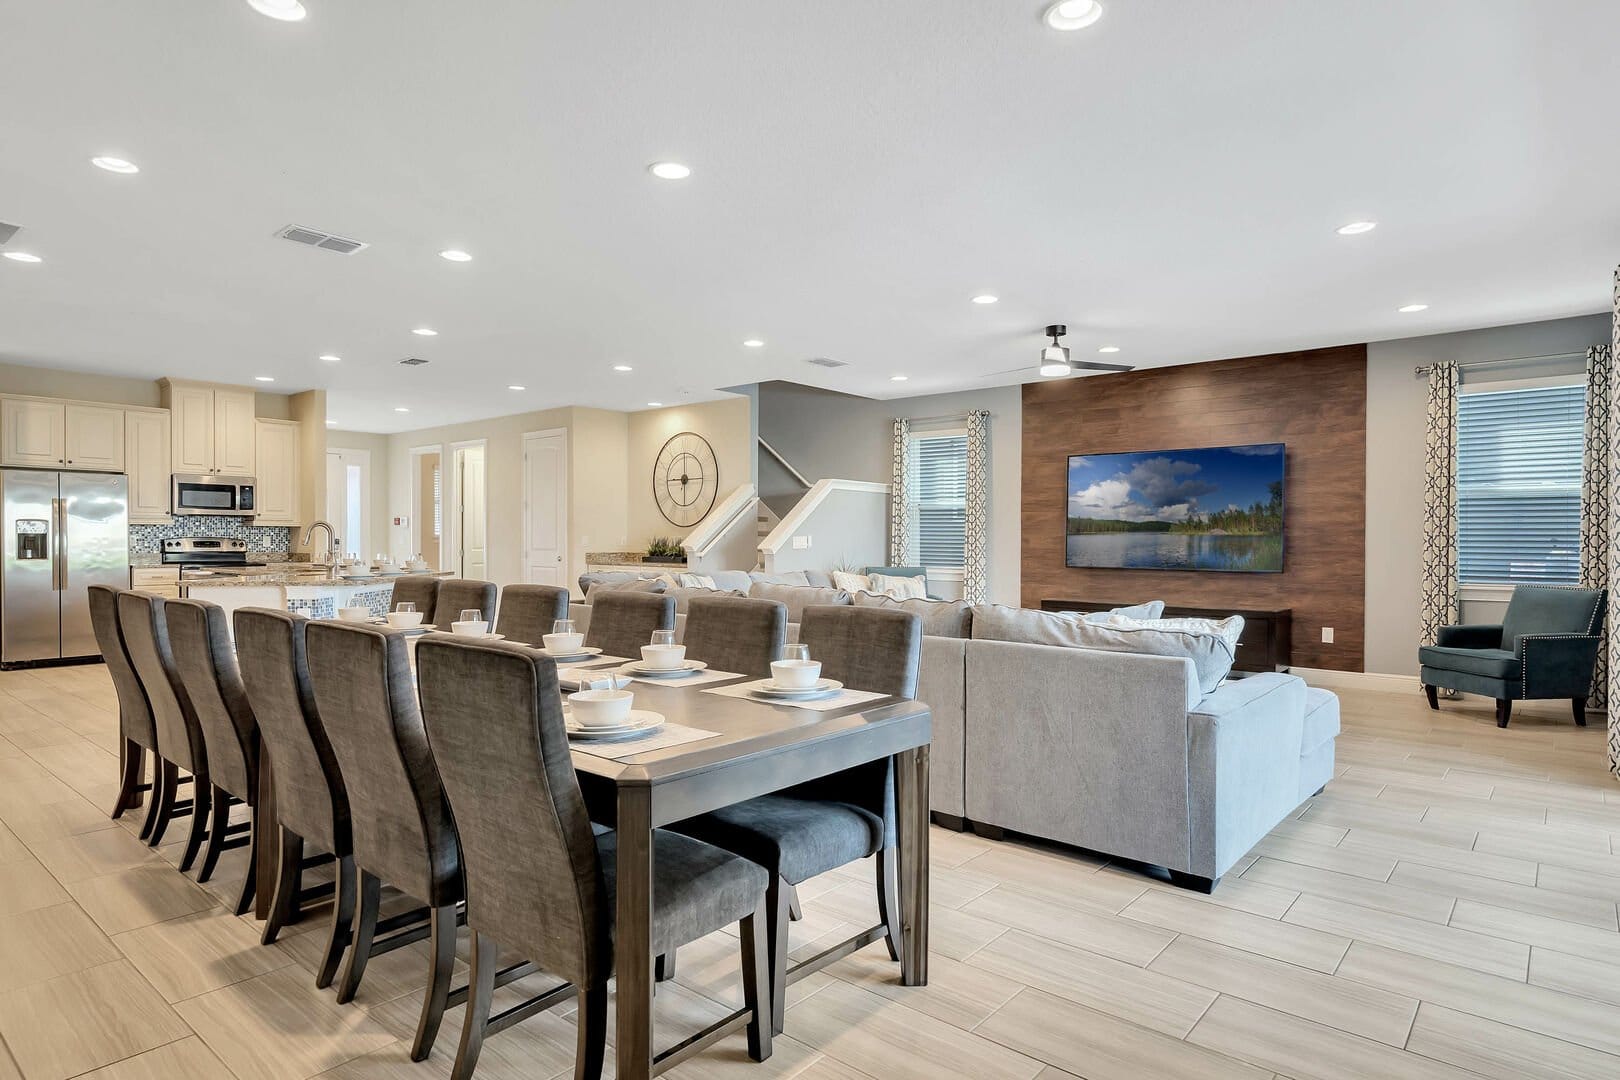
0, 470, 130, 665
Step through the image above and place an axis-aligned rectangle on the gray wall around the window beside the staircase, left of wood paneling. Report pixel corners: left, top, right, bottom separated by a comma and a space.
758, 382, 1024, 604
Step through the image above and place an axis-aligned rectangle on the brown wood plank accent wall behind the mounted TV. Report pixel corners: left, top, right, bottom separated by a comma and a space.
1022, 345, 1367, 672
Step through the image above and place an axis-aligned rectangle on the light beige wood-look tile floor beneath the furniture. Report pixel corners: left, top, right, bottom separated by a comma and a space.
0, 667, 1620, 1080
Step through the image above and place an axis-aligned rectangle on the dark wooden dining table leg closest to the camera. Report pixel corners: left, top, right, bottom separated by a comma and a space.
614, 785, 653, 1080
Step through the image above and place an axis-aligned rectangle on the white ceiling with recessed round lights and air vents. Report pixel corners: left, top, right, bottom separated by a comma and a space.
0, 0, 1620, 431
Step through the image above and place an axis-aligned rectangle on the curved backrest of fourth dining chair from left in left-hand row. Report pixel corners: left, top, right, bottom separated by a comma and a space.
235, 607, 353, 855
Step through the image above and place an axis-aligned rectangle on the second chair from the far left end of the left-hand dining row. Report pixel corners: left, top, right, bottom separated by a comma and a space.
118, 591, 209, 870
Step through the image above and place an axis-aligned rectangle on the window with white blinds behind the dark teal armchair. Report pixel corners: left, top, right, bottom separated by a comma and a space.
1456, 385, 1586, 585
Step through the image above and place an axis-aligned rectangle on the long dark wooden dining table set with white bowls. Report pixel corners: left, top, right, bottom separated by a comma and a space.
254, 650, 932, 1080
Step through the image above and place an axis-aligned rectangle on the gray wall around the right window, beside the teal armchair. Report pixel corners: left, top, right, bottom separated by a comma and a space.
1366, 314, 1610, 675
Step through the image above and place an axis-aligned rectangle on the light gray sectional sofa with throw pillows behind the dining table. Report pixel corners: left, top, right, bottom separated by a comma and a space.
570, 596, 1340, 891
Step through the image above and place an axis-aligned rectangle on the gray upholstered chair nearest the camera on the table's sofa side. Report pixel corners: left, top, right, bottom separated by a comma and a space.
674, 604, 922, 1035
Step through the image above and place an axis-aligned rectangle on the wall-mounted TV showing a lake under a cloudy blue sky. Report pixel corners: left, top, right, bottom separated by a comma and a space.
1064, 442, 1286, 573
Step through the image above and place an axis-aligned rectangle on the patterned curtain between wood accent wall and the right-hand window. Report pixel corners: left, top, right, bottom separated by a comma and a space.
1419, 361, 1460, 644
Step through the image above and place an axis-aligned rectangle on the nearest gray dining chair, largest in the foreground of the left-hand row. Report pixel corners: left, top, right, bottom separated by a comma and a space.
416, 635, 771, 1080
